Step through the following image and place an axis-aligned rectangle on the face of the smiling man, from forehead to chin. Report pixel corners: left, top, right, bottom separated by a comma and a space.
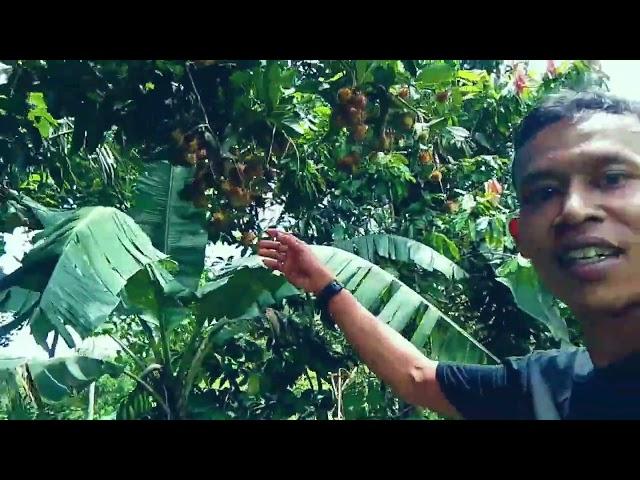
515, 112, 640, 314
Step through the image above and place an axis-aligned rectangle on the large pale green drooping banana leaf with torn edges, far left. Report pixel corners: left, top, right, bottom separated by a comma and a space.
0, 207, 166, 348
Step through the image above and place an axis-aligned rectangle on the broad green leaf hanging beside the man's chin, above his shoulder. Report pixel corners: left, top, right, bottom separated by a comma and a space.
497, 261, 569, 343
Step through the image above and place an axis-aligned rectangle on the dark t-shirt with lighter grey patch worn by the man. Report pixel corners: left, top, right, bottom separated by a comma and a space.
436, 348, 640, 420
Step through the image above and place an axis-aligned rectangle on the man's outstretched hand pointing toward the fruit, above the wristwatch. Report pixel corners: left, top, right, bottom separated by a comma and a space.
258, 229, 333, 294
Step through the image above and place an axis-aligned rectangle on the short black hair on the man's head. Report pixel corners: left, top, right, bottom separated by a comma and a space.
511, 90, 640, 187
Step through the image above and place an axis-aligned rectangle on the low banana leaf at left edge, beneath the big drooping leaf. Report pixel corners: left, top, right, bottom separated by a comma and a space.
0, 356, 123, 402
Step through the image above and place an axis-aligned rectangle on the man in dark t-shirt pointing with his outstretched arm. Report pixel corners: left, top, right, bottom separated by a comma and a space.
260, 93, 640, 419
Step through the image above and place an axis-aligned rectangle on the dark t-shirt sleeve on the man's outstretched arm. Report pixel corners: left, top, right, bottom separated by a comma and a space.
436, 359, 533, 420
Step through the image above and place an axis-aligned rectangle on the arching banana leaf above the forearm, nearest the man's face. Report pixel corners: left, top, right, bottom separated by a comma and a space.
334, 234, 467, 280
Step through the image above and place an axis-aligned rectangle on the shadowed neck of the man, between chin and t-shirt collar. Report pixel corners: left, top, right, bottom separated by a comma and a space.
578, 305, 640, 367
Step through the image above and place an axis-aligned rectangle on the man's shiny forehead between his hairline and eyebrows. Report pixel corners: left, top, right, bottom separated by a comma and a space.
514, 112, 640, 182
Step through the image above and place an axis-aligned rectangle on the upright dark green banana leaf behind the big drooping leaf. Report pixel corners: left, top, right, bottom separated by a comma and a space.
130, 160, 208, 290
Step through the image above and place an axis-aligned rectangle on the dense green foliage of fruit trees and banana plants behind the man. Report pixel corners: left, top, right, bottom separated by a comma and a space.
0, 60, 605, 419
